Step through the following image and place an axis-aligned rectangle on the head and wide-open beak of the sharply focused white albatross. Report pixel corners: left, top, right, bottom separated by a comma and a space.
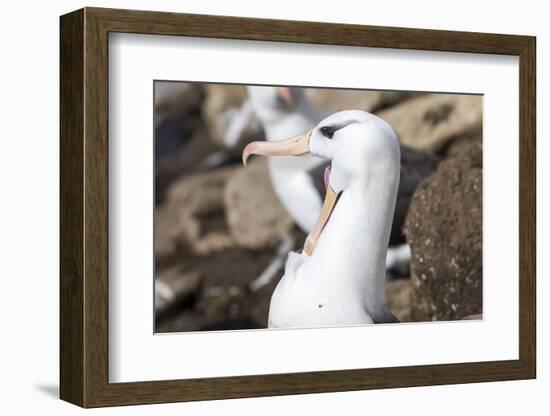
242, 110, 400, 255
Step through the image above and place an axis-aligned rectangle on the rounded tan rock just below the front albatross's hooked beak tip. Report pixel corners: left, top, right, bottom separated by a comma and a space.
224, 158, 293, 249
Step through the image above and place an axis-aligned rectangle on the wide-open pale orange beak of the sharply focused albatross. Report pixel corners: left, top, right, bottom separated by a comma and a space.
242, 130, 339, 256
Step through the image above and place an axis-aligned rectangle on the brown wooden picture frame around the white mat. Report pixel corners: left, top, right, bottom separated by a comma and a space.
60, 8, 536, 407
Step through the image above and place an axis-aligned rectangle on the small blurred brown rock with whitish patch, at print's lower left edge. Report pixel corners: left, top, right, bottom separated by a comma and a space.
155, 266, 201, 318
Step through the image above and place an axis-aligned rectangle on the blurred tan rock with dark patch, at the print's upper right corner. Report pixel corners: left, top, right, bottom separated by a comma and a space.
377, 94, 482, 152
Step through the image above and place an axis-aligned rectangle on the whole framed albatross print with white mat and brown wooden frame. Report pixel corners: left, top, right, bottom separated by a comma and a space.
60, 8, 536, 407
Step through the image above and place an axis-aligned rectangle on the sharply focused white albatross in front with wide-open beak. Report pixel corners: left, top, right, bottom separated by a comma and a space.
243, 110, 400, 327
